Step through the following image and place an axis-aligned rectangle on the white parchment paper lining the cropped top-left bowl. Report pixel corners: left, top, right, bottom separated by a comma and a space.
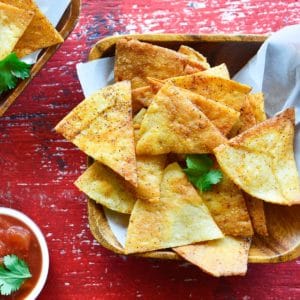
22, 0, 71, 64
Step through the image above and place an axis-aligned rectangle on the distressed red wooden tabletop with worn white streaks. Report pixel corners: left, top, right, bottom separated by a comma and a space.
0, 0, 300, 300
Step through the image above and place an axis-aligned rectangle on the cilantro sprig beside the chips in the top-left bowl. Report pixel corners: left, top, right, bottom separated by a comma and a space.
0, 53, 31, 95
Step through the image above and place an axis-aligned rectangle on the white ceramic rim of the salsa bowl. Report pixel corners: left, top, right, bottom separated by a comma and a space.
0, 207, 49, 300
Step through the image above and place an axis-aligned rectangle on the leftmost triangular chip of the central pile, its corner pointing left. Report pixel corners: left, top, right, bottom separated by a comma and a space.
55, 81, 137, 186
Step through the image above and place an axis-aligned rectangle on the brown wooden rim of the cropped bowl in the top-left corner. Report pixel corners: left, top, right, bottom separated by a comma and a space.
0, 0, 81, 117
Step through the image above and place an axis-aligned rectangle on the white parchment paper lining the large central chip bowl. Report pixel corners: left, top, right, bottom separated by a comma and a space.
77, 25, 300, 246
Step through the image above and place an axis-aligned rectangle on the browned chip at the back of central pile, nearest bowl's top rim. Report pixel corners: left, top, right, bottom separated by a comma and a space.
114, 39, 204, 89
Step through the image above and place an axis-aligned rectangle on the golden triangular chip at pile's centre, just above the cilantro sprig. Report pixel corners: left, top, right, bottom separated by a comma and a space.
136, 84, 227, 155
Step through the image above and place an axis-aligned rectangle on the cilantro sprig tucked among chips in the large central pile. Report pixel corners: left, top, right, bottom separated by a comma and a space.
184, 154, 223, 192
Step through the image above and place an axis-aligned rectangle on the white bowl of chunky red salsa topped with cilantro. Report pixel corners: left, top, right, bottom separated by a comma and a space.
0, 207, 49, 300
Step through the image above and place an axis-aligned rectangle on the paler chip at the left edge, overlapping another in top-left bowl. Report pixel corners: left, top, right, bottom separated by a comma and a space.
0, 2, 34, 59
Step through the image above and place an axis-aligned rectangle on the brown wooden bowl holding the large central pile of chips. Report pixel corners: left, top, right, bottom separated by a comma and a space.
88, 34, 300, 263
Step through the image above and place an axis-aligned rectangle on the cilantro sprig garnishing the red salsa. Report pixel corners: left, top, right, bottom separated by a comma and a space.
0, 254, 31, 296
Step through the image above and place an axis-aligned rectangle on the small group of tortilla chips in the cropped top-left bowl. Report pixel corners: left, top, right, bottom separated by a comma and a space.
0, 0, 63, 59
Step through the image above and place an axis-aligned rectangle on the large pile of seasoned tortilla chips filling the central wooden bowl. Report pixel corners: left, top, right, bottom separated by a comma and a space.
56, 39, 300, 276
